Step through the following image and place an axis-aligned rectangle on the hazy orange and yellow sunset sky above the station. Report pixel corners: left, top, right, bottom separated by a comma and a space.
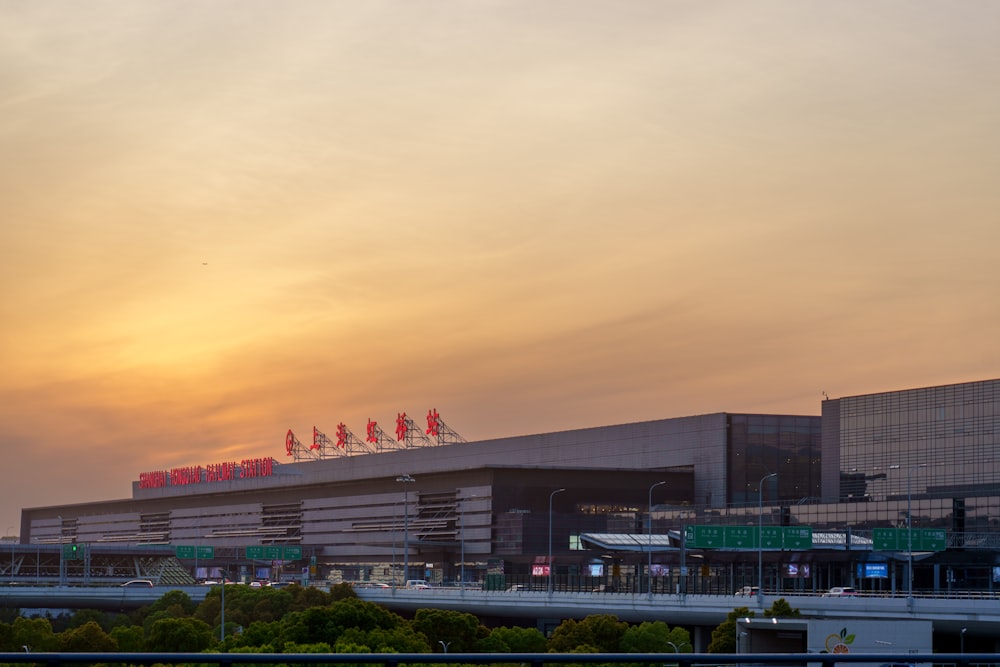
0, 0, 1000, 534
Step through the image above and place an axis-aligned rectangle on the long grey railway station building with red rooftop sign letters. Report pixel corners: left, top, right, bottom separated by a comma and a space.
20, 380, 1000, 594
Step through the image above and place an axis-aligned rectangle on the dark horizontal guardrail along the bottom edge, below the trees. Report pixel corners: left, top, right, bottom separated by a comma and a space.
0, 653, 998, 667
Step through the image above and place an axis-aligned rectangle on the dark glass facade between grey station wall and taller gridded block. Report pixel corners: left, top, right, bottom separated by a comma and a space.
727, 414, 821, 506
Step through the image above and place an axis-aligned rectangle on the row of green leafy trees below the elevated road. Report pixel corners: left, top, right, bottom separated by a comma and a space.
0, 585, 797, 653
